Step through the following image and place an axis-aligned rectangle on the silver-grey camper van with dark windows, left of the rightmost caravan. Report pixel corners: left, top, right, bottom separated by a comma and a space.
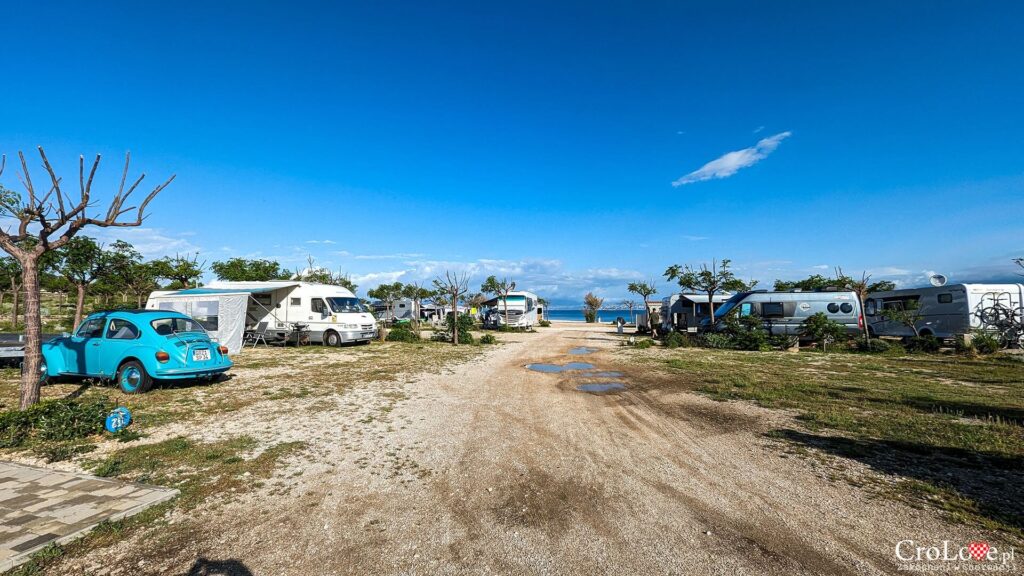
700, 290, 864, 335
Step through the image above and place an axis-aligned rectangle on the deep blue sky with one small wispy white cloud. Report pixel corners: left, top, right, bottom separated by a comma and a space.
0, 1, 1024, 304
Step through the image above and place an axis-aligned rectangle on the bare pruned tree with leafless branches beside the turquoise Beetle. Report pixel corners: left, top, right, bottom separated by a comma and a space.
0, 147, 174, 410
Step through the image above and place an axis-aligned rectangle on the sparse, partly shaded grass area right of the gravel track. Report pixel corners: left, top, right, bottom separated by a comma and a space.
633, 349, 1024, 540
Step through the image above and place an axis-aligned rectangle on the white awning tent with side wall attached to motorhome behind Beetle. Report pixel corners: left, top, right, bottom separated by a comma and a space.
145, 287, 276, 354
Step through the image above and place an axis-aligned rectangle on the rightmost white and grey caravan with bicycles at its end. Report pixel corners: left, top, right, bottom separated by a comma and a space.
864, 284, 1024, 345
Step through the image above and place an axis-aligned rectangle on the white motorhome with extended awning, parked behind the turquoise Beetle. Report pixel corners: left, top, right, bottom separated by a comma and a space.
145, 280, 377, 353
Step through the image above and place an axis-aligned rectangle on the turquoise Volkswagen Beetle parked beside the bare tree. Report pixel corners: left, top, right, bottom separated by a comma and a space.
40, 310, 231, 394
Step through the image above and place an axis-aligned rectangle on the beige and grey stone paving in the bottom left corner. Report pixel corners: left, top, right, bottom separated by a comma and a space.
0, 461, 178, 572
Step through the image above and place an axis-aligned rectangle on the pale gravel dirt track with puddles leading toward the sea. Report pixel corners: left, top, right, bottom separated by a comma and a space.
61, 325, 967, 575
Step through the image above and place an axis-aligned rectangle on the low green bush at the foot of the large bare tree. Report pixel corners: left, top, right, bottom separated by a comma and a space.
0, 398, 114, 448
